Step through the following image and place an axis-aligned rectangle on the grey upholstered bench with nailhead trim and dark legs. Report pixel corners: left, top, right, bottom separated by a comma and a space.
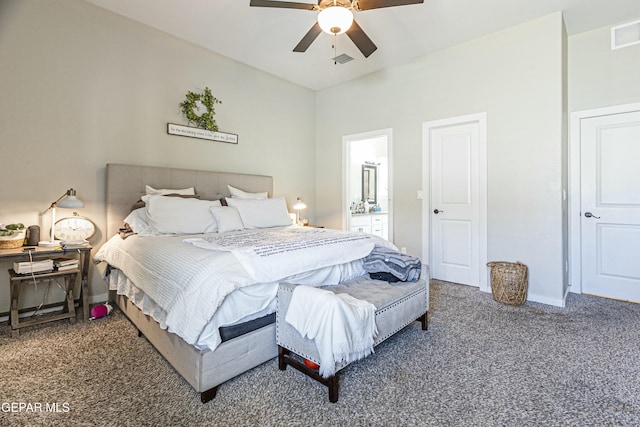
276, 276, 429, 403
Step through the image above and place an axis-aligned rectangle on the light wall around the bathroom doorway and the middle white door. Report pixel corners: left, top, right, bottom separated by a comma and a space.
316, 13, 566, 303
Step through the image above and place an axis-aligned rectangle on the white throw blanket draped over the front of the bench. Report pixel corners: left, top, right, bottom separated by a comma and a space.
285, 286, 378, 378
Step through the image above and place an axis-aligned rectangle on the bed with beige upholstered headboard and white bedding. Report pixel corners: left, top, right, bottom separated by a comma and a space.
95, 164, 392, 402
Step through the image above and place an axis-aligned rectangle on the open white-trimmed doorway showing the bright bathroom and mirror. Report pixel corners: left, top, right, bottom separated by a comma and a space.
342, 129, 393, 242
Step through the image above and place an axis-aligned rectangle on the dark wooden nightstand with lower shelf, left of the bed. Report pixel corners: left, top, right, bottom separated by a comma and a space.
0, 246, 92, 336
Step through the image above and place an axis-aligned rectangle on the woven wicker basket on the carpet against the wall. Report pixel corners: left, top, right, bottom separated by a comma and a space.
487, 261, 529, 305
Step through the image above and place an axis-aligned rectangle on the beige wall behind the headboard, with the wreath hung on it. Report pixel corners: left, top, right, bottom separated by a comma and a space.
0, 0, 315, 312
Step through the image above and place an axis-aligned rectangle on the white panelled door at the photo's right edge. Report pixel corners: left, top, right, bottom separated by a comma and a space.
580, 111, 640, 302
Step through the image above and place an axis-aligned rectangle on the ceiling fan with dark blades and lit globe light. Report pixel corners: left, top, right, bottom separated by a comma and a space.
249, 0, 424, 58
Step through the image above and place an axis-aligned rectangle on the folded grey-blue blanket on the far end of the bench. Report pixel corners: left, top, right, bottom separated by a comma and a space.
363, 246, 422, 282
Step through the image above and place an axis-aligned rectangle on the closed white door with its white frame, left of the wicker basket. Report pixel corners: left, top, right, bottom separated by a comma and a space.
422, 113, 489, 292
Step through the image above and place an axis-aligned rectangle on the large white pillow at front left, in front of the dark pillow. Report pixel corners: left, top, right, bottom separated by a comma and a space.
142, 194, 222, 234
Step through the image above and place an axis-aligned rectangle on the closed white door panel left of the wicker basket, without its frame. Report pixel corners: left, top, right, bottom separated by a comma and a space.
429, 122, 481, 286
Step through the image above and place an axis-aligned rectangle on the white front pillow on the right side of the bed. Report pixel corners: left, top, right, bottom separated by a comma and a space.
227, 197, 291, 228
